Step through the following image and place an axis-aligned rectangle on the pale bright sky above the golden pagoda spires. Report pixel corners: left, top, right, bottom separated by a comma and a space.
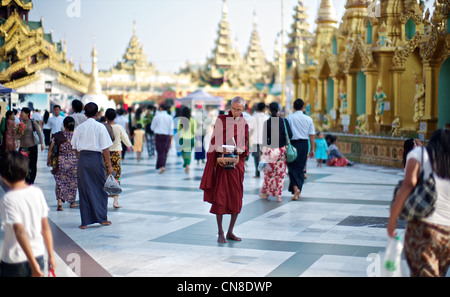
29, 0, 432, 72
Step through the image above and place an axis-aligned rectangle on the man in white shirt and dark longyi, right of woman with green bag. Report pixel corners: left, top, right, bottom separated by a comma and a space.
286, 99, 316, 200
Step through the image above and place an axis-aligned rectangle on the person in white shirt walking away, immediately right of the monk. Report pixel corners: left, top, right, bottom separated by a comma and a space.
251, 102, 269, 178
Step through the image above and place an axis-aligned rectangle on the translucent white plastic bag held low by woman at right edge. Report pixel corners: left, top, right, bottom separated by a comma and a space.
381, 236, 404, 277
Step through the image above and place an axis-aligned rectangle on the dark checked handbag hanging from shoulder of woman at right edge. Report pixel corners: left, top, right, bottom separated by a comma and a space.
391, 147, 437, 221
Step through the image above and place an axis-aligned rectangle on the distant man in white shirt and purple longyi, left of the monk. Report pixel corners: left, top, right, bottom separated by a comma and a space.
150, 104, 173, 173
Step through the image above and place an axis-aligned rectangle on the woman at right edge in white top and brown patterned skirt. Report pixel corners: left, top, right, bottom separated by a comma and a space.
387, 129, 450, 276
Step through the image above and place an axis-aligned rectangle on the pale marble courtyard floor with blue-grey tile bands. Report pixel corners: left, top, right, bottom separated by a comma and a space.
0, 149, 440, 277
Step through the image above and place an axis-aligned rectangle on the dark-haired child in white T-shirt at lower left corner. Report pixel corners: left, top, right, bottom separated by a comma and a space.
0, 151, 56, 277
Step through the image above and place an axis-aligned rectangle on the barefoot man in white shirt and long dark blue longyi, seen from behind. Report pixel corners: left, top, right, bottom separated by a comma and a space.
71, 102, 113, 229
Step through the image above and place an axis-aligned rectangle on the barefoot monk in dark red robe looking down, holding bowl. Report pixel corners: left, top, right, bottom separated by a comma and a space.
200, 97, 249, 243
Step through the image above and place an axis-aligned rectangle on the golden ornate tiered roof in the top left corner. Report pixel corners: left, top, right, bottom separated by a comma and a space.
0, 0, 89, 93
